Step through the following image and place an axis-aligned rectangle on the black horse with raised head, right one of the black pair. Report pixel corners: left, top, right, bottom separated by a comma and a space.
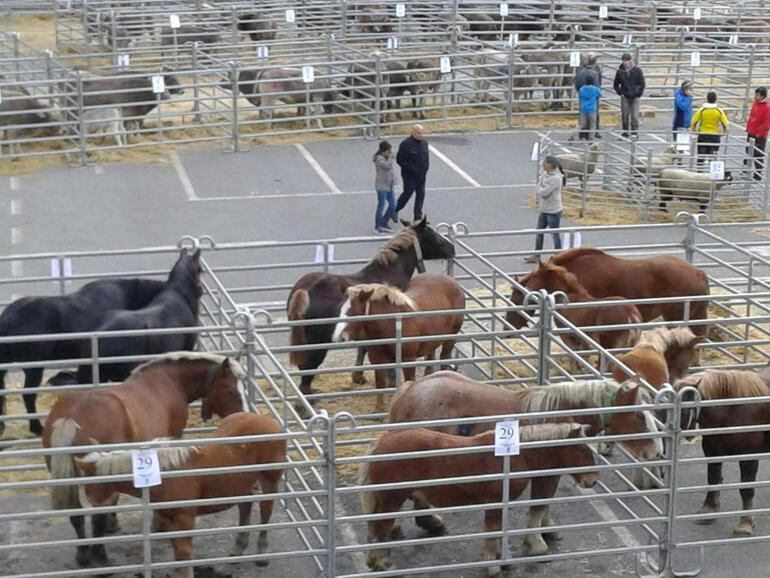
78, 249, 201, 383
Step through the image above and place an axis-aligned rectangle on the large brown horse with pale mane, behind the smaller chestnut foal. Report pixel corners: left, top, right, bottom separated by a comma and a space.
42, 351, 249, 566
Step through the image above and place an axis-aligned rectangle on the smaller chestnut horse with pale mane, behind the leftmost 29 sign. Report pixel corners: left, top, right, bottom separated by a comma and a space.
75, 412, 286, 578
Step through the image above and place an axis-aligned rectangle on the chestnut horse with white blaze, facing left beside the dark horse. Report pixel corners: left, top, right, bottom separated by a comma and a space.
332, 273, 465, 411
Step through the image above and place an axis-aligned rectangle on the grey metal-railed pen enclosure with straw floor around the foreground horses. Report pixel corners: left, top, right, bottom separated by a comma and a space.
0, 215, 770, 577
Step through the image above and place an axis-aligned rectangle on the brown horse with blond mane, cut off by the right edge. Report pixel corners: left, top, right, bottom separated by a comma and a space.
674, 369, 770, 536
